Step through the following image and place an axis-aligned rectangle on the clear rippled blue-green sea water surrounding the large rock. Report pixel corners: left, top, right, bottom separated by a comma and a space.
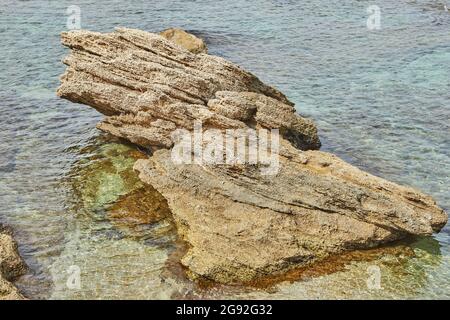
0, 0, 450, 299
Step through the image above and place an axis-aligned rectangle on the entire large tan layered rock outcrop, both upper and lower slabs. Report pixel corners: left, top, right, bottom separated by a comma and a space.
58, 28, 447, 283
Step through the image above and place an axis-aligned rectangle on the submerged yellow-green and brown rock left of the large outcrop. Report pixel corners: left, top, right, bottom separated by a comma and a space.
70, 142, 175, 245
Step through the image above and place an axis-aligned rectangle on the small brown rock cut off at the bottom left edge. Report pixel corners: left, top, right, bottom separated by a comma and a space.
0, 224, 26, 300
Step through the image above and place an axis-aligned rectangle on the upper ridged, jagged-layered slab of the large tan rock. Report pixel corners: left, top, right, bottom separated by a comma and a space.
58, 28, 320, 149
